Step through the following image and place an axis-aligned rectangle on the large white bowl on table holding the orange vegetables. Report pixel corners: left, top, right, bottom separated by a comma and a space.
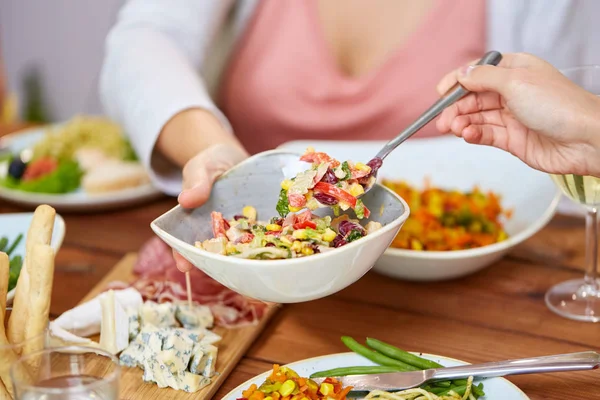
281, 136, 560, 281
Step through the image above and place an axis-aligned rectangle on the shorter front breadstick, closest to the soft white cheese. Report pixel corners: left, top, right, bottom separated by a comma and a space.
21, 244, 54, 371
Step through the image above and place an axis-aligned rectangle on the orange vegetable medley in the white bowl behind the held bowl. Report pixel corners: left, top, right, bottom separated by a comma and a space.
383, 180, 511, 251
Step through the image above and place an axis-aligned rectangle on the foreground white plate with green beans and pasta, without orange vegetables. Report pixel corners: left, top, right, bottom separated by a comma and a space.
223, 336, 529, 400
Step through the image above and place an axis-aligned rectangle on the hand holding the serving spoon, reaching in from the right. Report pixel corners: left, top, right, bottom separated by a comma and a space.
437, 54, 600, 176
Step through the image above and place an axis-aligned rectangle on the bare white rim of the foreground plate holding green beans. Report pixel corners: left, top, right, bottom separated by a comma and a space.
223, 353, 529, 400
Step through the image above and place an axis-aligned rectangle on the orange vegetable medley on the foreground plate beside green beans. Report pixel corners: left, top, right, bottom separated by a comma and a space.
238, 364, 352, 400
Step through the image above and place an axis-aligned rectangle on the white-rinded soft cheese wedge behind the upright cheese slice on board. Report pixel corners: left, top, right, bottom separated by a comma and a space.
50, 288, 143, 336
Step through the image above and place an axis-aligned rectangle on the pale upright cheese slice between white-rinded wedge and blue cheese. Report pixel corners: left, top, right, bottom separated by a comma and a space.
100, 290, 129, 354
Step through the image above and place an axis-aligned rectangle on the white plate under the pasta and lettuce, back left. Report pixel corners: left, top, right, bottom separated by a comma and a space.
0, 127, 161, 212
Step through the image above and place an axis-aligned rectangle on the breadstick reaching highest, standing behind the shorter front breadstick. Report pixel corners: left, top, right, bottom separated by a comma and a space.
7, 205, 56, 353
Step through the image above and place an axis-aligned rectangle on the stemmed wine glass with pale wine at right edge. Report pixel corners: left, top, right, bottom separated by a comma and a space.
546, 65, 600, 322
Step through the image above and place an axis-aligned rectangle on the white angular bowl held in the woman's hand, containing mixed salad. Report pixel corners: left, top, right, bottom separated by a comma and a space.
151, 151, 409, 303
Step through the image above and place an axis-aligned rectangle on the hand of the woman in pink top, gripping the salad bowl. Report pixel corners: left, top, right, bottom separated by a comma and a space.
157, 109, 248, 272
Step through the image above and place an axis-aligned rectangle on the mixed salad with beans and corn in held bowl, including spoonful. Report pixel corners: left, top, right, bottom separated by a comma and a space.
195, 148, 381, 260
